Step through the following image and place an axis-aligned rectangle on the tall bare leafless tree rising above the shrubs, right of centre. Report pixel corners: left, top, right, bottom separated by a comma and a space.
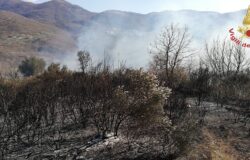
150, 24, 191, 89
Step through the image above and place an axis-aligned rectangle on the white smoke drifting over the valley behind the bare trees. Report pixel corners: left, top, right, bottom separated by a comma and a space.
61, 10, 245, 68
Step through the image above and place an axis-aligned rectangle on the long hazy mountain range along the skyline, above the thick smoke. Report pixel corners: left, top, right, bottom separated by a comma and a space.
0, 0, 245, 39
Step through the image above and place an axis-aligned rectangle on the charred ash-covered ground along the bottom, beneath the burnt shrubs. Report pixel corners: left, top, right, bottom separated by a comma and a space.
4, 102, 250, 160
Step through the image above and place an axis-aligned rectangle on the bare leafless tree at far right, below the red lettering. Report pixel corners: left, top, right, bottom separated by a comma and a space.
205, 40, 249, 107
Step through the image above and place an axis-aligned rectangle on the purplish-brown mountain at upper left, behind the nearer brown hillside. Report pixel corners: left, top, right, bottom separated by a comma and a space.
0, 0, 95, 33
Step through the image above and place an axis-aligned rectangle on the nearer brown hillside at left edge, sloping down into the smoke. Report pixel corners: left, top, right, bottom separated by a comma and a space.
0, 11, 76, 70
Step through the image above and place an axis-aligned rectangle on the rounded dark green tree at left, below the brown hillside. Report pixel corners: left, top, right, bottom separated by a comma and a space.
18, 57, 46, 77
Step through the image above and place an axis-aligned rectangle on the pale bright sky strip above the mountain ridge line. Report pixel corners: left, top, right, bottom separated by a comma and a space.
22, 0, 250, 13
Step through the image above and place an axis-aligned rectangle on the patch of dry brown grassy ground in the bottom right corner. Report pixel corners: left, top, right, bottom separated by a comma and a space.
185, 100, 250, 160
